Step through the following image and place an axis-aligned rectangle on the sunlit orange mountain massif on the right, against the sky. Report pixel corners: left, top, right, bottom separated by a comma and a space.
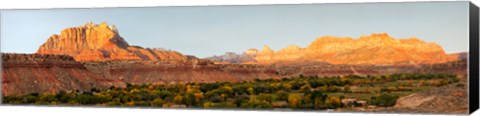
255, 33, 458, 64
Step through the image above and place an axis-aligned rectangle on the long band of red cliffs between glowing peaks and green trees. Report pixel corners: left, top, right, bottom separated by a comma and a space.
1, 54, 467, 95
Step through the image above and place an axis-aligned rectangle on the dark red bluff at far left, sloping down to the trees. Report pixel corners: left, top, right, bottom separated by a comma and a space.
2, 54, 125, 95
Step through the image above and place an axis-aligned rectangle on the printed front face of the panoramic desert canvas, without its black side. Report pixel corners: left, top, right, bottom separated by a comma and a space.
1, 1, 476, 114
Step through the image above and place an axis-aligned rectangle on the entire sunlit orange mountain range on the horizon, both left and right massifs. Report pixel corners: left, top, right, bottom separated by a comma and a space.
37, 22, 459, 64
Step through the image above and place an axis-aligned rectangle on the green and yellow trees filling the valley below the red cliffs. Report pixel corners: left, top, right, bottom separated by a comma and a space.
2, 74, 458, 109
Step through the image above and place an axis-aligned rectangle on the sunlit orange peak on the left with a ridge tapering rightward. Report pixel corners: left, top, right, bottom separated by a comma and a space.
37, 22, 186, 61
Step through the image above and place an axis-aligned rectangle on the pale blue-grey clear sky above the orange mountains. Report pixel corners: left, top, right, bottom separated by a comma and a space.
0, 1, 468, 58
